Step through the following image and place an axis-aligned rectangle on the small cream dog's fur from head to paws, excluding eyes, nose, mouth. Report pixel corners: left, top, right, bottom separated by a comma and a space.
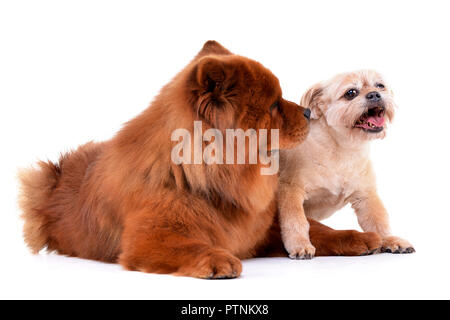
278, 70, 414, 259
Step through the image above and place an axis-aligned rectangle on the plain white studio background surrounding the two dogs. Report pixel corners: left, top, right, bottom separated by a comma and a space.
0, 0, 450, 299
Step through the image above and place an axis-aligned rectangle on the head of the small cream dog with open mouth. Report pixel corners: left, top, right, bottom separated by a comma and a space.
300, 70, 395, 140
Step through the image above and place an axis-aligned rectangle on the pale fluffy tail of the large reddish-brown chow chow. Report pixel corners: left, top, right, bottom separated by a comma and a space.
18, 161, 61, 253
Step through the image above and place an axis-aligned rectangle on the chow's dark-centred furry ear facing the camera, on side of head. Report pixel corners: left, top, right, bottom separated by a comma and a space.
189, 57, 239, 129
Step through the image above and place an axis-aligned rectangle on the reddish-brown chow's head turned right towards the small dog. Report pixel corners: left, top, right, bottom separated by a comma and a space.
187, 41, 309, 149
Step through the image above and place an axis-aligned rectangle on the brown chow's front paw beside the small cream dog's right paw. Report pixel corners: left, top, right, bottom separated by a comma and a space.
341, 230, 382, 256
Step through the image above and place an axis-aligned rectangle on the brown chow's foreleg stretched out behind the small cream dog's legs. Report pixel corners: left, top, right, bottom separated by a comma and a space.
257, 219, 382, 257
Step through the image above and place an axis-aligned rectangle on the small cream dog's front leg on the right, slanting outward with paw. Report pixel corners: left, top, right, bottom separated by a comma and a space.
352, 191, 415, 253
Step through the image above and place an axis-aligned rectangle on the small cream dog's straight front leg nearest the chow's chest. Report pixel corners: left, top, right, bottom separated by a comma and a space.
278, 184, 316, 259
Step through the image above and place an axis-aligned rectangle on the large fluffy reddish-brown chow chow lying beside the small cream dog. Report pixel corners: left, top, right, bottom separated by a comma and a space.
20, 41, 380, 278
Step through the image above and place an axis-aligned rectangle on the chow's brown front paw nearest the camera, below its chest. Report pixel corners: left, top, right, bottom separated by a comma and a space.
178, 249, 242, 279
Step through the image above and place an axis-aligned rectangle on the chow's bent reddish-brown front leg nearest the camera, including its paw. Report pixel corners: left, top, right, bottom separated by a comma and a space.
119, 205, 242, 279
